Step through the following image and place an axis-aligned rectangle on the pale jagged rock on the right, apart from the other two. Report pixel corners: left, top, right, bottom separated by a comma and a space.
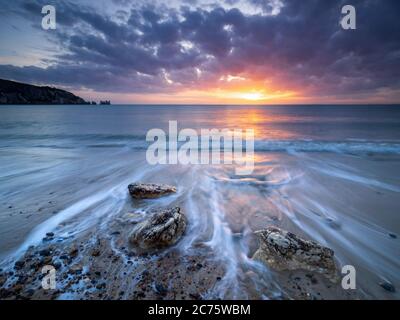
253, 227, 337, 282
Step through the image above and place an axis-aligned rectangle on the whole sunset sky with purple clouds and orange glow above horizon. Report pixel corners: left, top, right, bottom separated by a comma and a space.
0, 0, 400, 104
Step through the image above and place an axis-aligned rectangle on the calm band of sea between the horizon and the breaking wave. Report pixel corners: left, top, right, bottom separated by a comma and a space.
0, 106, 400, 152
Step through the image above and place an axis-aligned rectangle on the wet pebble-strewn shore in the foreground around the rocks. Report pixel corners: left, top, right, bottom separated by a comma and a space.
0, 182, 361, 300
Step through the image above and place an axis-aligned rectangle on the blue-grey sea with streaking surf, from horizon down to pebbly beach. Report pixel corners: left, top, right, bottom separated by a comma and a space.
0, 106, 400, 298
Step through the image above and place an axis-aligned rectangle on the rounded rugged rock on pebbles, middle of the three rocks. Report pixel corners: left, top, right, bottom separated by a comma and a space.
129, 207, 186, 250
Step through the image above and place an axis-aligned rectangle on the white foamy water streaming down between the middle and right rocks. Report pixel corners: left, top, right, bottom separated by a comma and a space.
179, 167, 280, 299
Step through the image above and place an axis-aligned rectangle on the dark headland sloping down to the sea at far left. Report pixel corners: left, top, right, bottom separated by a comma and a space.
0, 79, 94, 104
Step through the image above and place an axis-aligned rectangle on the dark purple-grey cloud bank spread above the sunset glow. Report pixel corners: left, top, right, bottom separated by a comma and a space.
0, 0, 400, 96
